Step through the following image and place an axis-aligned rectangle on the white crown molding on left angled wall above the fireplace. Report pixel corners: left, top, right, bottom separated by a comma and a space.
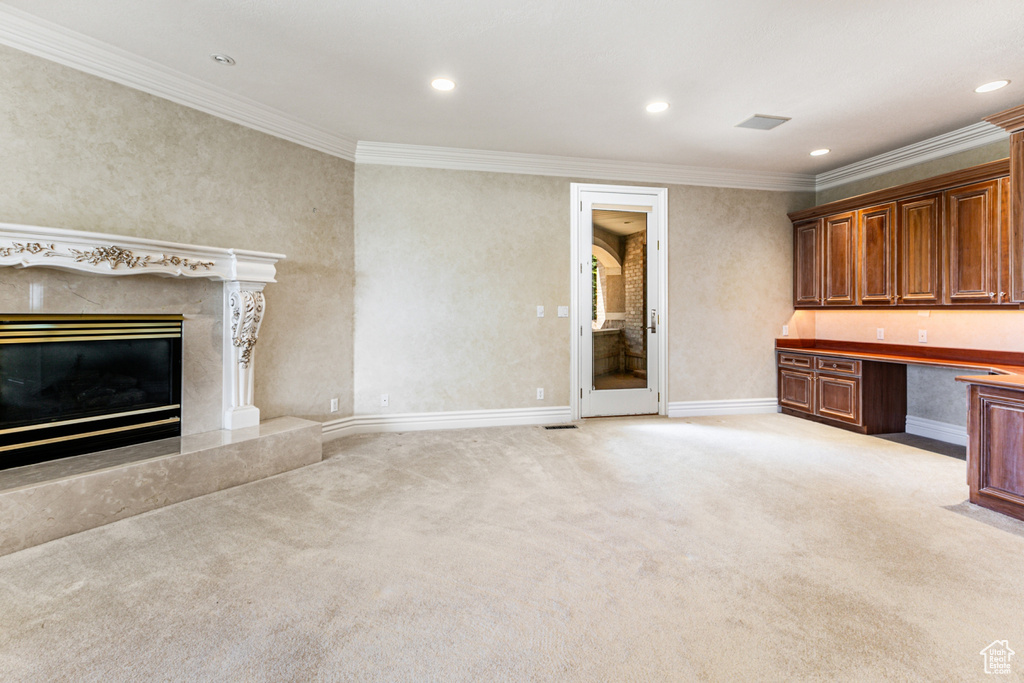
0, 5, 355, 161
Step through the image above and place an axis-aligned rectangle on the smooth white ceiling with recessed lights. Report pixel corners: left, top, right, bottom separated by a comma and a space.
0, 0, 1024, 174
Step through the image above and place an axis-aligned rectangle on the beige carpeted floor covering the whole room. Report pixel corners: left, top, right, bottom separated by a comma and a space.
0, 415, 1024, 682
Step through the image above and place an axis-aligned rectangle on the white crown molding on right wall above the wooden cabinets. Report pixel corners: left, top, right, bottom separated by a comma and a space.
815, 122, 1010, 191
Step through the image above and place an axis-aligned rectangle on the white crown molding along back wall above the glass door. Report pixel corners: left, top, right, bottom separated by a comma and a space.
355, 140, 815, 191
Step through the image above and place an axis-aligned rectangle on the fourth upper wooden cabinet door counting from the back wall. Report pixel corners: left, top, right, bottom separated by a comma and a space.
896, 189, 942, 304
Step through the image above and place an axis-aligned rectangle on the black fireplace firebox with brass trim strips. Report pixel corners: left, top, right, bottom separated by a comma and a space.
0, 314, 183, 469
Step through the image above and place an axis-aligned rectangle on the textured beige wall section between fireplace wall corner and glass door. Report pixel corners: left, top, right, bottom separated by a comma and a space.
354, 164, 569, 414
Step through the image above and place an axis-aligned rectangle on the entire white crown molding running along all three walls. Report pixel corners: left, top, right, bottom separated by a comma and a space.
0, 4, 1009, 191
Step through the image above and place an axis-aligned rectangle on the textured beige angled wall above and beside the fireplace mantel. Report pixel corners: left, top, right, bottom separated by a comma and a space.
0, 46, 353, 420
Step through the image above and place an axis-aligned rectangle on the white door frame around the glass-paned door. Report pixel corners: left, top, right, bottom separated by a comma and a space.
569, 182, 669, 420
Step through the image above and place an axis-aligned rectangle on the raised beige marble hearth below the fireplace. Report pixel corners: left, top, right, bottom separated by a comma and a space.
0, 418, 323, 555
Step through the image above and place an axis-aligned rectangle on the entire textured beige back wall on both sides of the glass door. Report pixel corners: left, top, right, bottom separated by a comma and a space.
354, 165, 813, 414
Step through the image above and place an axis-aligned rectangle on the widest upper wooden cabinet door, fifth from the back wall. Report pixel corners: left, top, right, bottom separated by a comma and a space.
945, 180, 999, 304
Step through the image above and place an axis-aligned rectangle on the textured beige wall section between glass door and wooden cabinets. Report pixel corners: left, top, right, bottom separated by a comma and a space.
669, 185, 813, 401
